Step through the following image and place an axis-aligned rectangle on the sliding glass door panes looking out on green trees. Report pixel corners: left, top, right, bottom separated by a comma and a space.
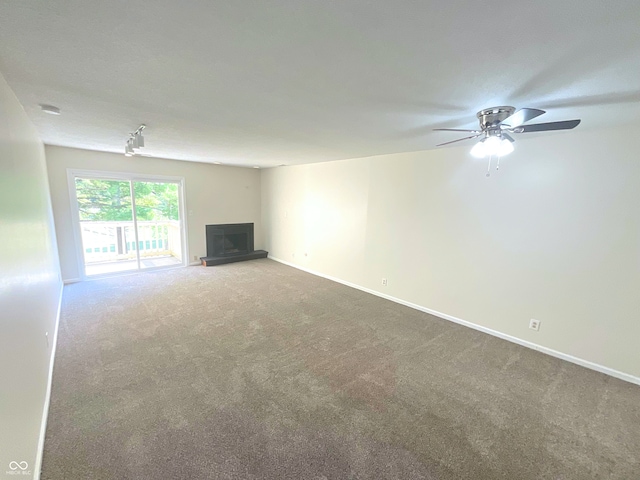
69, 172, 185, 277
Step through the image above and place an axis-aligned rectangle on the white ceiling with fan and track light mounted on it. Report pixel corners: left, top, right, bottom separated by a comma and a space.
0, 0, 640, 167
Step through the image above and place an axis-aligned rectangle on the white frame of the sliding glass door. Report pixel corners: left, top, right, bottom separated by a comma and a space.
67, 168, 190, 281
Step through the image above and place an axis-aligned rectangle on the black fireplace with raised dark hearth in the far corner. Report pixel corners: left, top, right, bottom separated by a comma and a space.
200, 223, 268, 267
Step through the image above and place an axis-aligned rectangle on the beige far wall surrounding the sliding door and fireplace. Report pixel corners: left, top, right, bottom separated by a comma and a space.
46, 146, 262, 280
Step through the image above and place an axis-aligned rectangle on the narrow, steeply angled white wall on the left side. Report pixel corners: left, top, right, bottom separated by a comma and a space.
0, 76, 62, 478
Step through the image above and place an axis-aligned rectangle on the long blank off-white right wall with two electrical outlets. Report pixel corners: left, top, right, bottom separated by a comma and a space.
262, 125, 640, 377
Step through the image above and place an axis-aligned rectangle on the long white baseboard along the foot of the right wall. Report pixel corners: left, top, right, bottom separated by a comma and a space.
269, 255, 640, 385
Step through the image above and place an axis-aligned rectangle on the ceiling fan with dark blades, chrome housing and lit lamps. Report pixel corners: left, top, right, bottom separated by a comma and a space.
434, 107, 580, 176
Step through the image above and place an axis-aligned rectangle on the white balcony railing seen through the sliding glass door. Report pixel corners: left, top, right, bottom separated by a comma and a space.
80, 220, 182, 263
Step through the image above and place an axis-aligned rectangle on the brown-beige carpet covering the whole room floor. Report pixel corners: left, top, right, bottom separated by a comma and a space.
42, 259, 640, 480
